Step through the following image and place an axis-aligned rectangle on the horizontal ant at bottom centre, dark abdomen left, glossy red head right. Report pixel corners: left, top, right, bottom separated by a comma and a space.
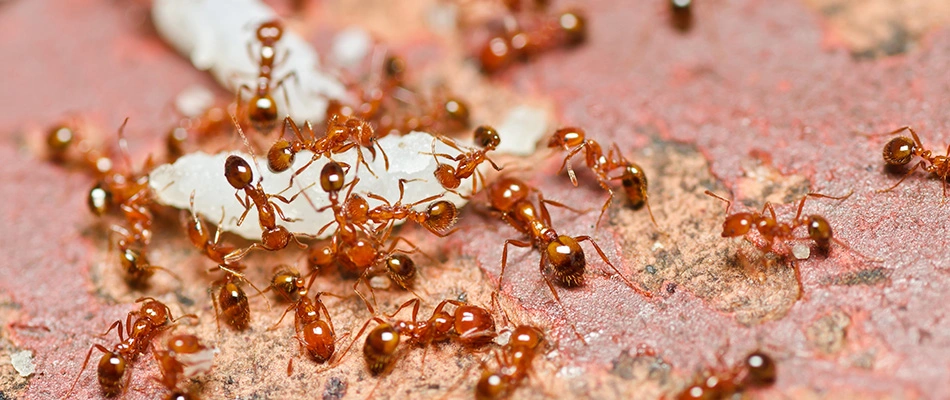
343, 299, 497, 375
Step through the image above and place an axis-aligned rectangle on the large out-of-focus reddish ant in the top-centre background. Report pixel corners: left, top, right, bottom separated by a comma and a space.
478, 4, 587, 74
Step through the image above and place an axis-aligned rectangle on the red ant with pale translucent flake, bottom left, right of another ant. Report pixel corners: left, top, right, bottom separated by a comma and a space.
152, 334, 214, 399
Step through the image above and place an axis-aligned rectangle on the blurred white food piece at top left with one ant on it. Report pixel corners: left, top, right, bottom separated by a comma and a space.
152, 0, 346, 123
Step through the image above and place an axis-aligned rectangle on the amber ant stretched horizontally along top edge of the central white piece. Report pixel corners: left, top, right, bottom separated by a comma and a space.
267, 114, 389, 180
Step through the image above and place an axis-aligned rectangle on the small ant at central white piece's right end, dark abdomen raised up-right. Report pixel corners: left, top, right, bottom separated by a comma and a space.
432, 125, 501, 197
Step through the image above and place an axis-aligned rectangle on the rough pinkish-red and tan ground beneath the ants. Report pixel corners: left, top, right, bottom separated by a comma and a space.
0, 0, 950, 398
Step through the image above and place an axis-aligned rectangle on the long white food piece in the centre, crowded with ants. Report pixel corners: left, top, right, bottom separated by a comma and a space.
149, 132, 472, 240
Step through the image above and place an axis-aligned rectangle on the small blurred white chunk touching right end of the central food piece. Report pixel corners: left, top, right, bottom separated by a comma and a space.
495, 105, 551, 156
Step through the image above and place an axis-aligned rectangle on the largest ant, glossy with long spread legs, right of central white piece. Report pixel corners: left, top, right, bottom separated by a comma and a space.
488, 177, 652, 341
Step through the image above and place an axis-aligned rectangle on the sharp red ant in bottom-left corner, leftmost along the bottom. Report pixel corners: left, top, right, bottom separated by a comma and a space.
63, 297, 198, 398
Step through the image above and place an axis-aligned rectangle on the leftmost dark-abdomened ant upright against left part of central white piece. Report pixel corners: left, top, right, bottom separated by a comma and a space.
224, 155, 307, 263
